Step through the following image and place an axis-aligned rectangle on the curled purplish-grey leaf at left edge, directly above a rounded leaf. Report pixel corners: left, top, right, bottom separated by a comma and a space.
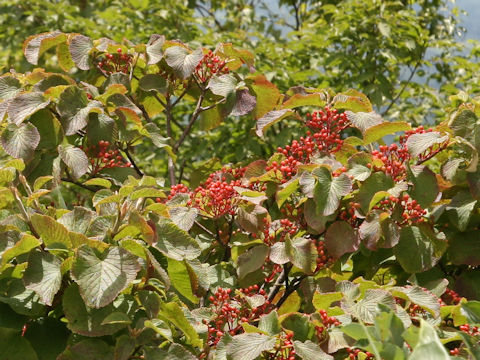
7, 91, 50, 125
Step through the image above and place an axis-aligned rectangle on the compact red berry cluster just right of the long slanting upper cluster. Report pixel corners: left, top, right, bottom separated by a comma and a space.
372, 143, 410, 181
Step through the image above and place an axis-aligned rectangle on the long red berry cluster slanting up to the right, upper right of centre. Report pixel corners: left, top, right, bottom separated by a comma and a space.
266, 107, 351, 183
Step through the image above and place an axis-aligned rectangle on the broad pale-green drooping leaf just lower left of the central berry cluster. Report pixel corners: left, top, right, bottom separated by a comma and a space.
154, 220, 201, 261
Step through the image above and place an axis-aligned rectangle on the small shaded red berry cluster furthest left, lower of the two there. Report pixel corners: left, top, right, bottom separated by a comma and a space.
80, 140, 132, 175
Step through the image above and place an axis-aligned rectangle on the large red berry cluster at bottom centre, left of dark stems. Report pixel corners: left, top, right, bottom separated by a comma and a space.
204, 285, 270, 346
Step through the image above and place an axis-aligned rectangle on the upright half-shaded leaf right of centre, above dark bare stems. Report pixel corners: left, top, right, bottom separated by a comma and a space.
285, 237, 317, 274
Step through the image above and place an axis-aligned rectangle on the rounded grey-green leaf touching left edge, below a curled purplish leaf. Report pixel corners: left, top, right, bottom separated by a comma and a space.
0, 123, 40, 159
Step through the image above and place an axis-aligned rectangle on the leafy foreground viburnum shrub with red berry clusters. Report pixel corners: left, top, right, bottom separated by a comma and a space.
0, 31, 480, 360
